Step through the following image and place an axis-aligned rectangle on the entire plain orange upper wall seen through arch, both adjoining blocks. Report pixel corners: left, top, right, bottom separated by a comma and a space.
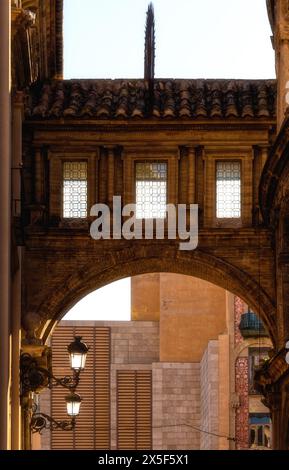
131, 273, 227, 362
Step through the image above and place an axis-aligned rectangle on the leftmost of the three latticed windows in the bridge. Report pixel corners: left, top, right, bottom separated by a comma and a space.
63, 162, 87, 218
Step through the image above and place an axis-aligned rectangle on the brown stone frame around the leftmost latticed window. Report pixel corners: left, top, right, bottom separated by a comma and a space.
48, 149, 99, 226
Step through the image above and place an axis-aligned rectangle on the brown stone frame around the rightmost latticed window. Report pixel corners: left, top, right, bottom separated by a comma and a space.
203, 147, 253, 228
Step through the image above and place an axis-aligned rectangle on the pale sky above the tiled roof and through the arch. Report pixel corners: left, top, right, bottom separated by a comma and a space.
64, 0, 275, 320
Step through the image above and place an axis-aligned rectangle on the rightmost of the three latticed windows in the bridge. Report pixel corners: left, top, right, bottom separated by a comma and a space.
216, 161, 241, 219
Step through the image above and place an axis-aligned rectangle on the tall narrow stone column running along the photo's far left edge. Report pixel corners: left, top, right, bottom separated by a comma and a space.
0, 0, 11, 450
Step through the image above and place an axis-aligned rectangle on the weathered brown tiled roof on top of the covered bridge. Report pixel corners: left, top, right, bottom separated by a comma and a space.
25, 79, 276, 120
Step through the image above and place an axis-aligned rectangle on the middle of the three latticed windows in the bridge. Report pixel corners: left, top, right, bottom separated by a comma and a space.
136, 162, 167, 219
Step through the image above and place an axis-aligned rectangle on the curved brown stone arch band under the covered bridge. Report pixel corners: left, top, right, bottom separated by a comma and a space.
28, 244, 276, 344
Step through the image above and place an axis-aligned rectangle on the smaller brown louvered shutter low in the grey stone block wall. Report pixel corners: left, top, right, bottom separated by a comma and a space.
117, 370, 152, 450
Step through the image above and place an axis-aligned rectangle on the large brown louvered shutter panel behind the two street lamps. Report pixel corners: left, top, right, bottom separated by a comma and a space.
51, 326, 110, 450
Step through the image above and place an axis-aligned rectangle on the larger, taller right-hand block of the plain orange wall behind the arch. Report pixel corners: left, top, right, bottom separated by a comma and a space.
160, 273, 227, 362
